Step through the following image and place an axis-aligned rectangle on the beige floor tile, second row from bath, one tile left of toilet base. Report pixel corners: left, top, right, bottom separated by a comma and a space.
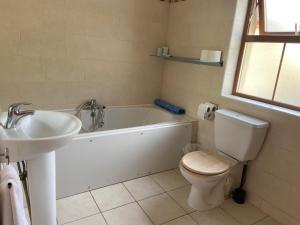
139, 194, 186, 224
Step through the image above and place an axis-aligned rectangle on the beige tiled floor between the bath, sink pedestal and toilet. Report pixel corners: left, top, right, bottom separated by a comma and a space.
57, 170, 278, 225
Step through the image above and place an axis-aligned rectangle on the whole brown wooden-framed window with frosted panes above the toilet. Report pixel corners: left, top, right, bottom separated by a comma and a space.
233, 0, 300, 111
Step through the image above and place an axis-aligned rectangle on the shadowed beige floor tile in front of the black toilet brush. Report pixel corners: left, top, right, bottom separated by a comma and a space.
221, 199, 266, 225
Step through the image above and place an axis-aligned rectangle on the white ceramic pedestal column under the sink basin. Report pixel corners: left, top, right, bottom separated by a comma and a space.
27, 152, 56, 225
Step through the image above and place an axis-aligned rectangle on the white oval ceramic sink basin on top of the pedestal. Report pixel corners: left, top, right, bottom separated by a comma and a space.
0, 111, 82, 162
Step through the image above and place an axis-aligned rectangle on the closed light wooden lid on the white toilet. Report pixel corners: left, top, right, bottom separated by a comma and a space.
182, 150, 231, 175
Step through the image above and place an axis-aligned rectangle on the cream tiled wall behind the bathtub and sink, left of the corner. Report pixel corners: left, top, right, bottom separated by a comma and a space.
0, 0, 169, 109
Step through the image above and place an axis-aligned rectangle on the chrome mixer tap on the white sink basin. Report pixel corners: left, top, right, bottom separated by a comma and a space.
0, 102, 34, 129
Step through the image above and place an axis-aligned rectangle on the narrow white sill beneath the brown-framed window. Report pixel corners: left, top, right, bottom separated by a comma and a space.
222, 95, 300, 118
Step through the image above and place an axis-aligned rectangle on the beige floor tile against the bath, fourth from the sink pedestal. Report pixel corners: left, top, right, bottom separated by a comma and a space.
151, 170, 189, 191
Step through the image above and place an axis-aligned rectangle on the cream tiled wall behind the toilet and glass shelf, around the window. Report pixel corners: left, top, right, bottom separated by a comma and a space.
162, 0, 300, 225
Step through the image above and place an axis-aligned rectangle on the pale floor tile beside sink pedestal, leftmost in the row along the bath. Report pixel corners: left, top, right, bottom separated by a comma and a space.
57, 192, 99, 224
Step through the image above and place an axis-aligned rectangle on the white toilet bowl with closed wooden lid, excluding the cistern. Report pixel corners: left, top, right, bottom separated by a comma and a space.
179, 150, 236, 211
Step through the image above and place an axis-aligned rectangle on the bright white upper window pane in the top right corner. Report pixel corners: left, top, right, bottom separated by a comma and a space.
265, 0, 300, 32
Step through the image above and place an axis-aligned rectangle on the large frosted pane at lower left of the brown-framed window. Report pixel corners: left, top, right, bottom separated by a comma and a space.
237, 42, 284, 100
